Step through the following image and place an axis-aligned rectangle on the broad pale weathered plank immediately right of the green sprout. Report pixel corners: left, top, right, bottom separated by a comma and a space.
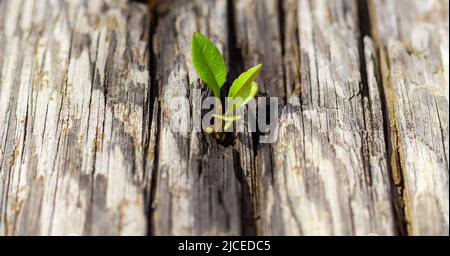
244, 0, 395, 235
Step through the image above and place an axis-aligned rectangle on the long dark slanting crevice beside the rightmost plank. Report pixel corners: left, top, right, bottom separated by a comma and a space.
364, 0, 407, 235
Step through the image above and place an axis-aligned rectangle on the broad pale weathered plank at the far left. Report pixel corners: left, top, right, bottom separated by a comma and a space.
0, 0, 149, 235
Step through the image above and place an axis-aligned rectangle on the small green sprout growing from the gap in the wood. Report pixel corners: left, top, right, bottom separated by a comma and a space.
192, 33, 262, 140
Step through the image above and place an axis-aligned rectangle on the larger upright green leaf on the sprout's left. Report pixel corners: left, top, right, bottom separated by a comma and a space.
192, 33, 227, 98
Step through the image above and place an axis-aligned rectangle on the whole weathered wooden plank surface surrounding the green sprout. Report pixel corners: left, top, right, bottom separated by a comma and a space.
0, 0, 449, 235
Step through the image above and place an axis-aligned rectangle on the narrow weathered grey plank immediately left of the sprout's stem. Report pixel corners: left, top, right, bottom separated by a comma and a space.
151, 0, 242, 235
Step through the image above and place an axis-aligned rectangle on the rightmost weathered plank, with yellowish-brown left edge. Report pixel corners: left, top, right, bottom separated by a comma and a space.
368, 0, 448, 235
